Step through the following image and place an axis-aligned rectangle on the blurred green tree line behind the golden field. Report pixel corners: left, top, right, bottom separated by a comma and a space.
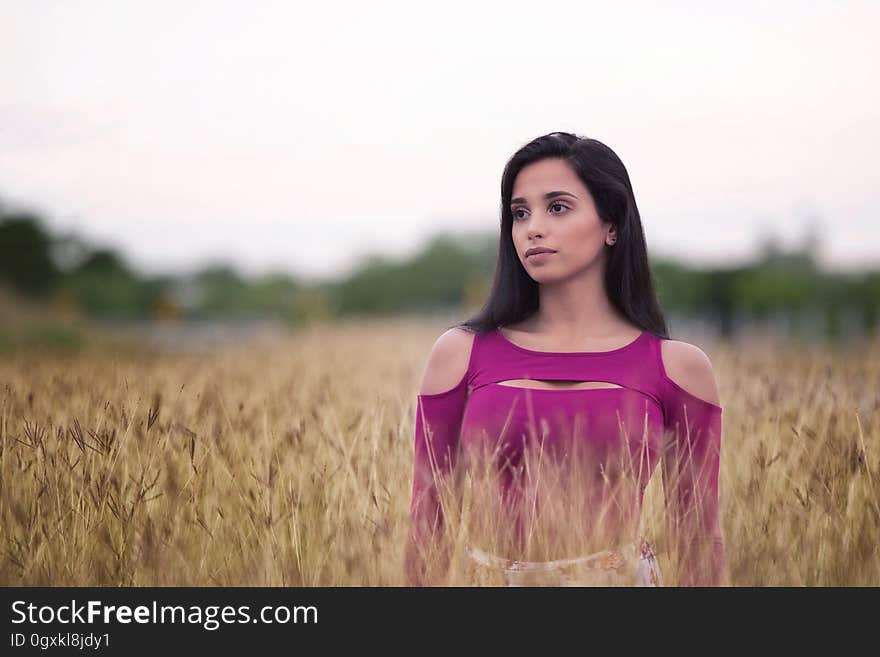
0, 199, 880, 337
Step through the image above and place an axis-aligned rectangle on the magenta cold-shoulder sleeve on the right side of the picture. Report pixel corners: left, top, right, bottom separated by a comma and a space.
661, 373, 726, 586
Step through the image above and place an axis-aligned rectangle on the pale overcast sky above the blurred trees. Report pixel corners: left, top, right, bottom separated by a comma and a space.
0, 0, 880, 276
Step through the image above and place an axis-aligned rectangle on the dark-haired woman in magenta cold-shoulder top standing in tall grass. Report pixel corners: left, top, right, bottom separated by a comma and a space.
405, 132, 725, 586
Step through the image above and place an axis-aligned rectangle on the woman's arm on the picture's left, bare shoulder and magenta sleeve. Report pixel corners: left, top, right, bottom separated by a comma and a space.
404, 328, 474, 586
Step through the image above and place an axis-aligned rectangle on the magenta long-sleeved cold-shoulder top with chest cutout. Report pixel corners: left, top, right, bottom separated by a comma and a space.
405, 329, 725, 586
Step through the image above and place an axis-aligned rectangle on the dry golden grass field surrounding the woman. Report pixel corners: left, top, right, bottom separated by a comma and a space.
0, 319, 880, 586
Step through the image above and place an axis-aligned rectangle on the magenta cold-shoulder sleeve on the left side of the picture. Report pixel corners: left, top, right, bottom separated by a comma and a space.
404, 377, 468, 586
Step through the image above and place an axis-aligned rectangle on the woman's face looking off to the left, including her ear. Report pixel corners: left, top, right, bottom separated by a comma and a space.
510, 158, 617, 283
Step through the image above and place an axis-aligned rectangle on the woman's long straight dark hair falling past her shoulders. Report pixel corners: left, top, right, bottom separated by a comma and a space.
455, 132, 669, 338
